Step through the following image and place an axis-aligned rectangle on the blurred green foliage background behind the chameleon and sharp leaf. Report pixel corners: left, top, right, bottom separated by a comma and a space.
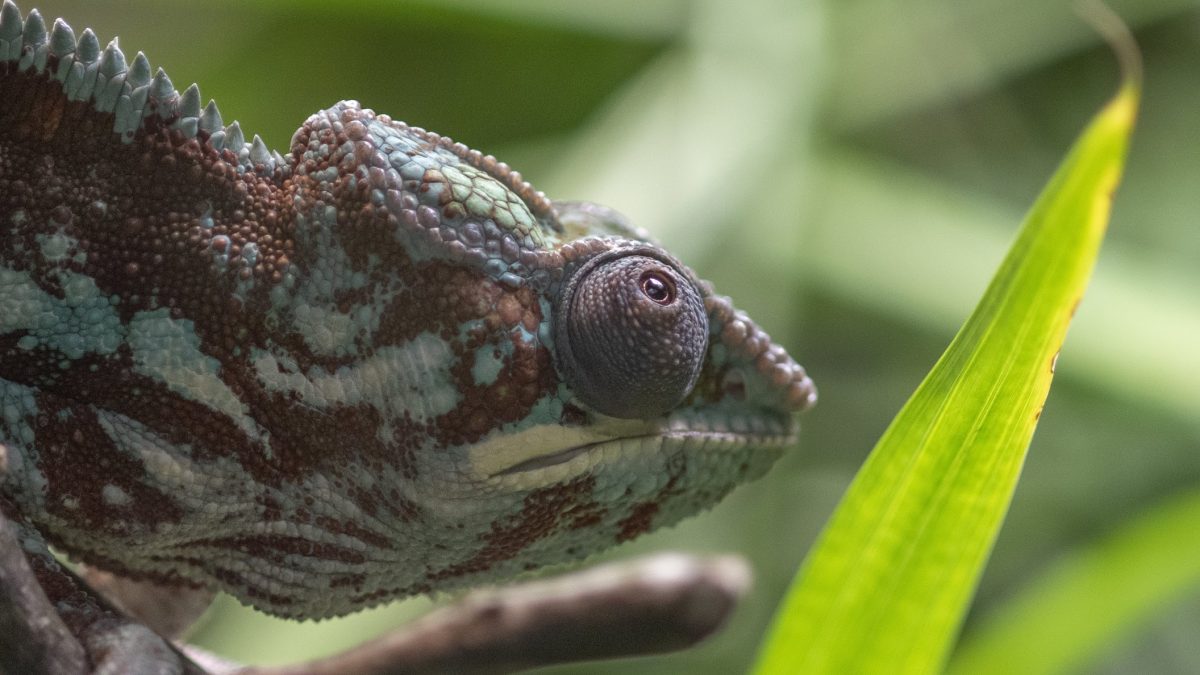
20, 0, 1200, 674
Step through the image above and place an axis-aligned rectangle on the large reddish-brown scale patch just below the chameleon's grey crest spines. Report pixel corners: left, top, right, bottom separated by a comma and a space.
0, 73, 292, 307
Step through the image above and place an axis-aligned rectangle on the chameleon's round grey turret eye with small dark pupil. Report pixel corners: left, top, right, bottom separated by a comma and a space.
554, 253, 708, 419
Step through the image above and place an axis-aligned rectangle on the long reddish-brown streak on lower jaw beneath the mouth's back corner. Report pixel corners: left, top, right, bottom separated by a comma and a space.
426, 476, 595, 584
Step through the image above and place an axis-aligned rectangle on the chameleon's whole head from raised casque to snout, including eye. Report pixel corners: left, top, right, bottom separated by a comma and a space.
272, 102, 816, 615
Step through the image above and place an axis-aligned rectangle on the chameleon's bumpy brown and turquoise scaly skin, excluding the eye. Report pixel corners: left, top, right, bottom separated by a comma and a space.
0, 1, 815, 617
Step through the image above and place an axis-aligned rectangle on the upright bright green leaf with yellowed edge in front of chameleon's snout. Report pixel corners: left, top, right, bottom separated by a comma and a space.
757, 44, 1140, 674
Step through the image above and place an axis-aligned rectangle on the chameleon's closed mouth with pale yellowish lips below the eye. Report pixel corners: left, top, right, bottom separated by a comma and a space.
477, 414, 798, 480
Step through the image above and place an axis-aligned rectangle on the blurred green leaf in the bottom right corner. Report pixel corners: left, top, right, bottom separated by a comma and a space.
949, 490, 1200, 675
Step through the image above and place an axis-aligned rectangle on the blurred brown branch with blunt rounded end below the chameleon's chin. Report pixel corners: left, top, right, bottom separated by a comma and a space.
206, 554, 750, 675
